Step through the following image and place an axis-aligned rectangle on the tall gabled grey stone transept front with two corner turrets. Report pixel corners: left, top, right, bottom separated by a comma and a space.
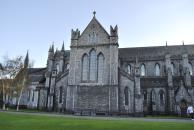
66, 12, 118, 114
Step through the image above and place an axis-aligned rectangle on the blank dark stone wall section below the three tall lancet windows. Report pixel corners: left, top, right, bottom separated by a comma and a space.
74, 86, 118, 113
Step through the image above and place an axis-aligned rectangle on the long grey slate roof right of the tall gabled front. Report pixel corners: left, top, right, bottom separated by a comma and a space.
119, 45, 194, 59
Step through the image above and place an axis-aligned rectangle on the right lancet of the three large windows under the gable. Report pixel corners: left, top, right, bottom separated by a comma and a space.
97, 53, 104, 83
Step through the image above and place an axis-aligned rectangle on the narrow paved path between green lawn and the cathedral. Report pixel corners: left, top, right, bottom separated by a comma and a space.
0, 110, 194, 123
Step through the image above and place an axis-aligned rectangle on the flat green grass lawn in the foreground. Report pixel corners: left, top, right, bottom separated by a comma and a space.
0, 112, 194, 130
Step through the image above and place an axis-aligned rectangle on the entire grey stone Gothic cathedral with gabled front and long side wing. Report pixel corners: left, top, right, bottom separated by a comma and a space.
16, 13, 194, 116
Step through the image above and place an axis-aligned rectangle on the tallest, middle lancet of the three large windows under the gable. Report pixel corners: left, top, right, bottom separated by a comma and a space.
89, 50, 96, 81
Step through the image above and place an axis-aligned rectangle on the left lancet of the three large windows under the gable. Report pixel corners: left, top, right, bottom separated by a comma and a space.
82, 54, 88, 81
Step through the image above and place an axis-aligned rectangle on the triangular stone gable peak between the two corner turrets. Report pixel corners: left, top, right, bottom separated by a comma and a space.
78, 16, 109, 45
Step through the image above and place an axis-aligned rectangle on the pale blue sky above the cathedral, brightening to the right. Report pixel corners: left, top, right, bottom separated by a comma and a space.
0, 0, 194, 67
